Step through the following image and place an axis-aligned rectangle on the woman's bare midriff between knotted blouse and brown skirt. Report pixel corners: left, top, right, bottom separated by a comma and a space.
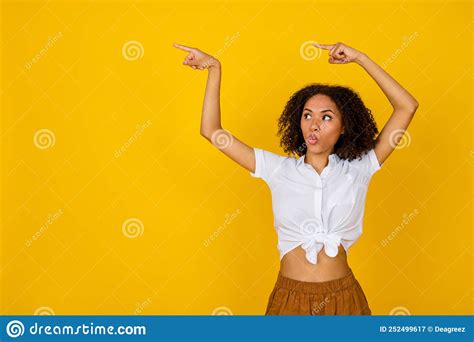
280, 245, 350, 282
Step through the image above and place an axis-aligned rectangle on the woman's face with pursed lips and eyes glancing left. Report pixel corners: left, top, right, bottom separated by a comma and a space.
301, 94, 344, 153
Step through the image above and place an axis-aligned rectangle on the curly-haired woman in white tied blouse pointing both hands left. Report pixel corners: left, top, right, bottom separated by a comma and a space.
174, 43, 418, 315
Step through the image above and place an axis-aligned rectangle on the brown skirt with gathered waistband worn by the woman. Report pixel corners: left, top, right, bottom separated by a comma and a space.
265, 270, 372, 315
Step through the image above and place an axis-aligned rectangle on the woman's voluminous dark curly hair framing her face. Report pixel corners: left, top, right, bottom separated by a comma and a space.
278, 83, 378, 161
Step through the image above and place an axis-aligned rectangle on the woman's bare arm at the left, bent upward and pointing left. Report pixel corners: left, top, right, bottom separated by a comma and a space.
173, 44, 256, 172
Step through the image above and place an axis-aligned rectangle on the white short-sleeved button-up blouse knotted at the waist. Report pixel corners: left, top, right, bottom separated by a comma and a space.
250, 147, 380, 264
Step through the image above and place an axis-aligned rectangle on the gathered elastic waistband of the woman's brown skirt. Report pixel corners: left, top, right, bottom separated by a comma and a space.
276, 269, 357, 294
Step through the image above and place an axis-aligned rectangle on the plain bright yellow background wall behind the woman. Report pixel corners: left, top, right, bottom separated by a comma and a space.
1, 1, 473, 315
